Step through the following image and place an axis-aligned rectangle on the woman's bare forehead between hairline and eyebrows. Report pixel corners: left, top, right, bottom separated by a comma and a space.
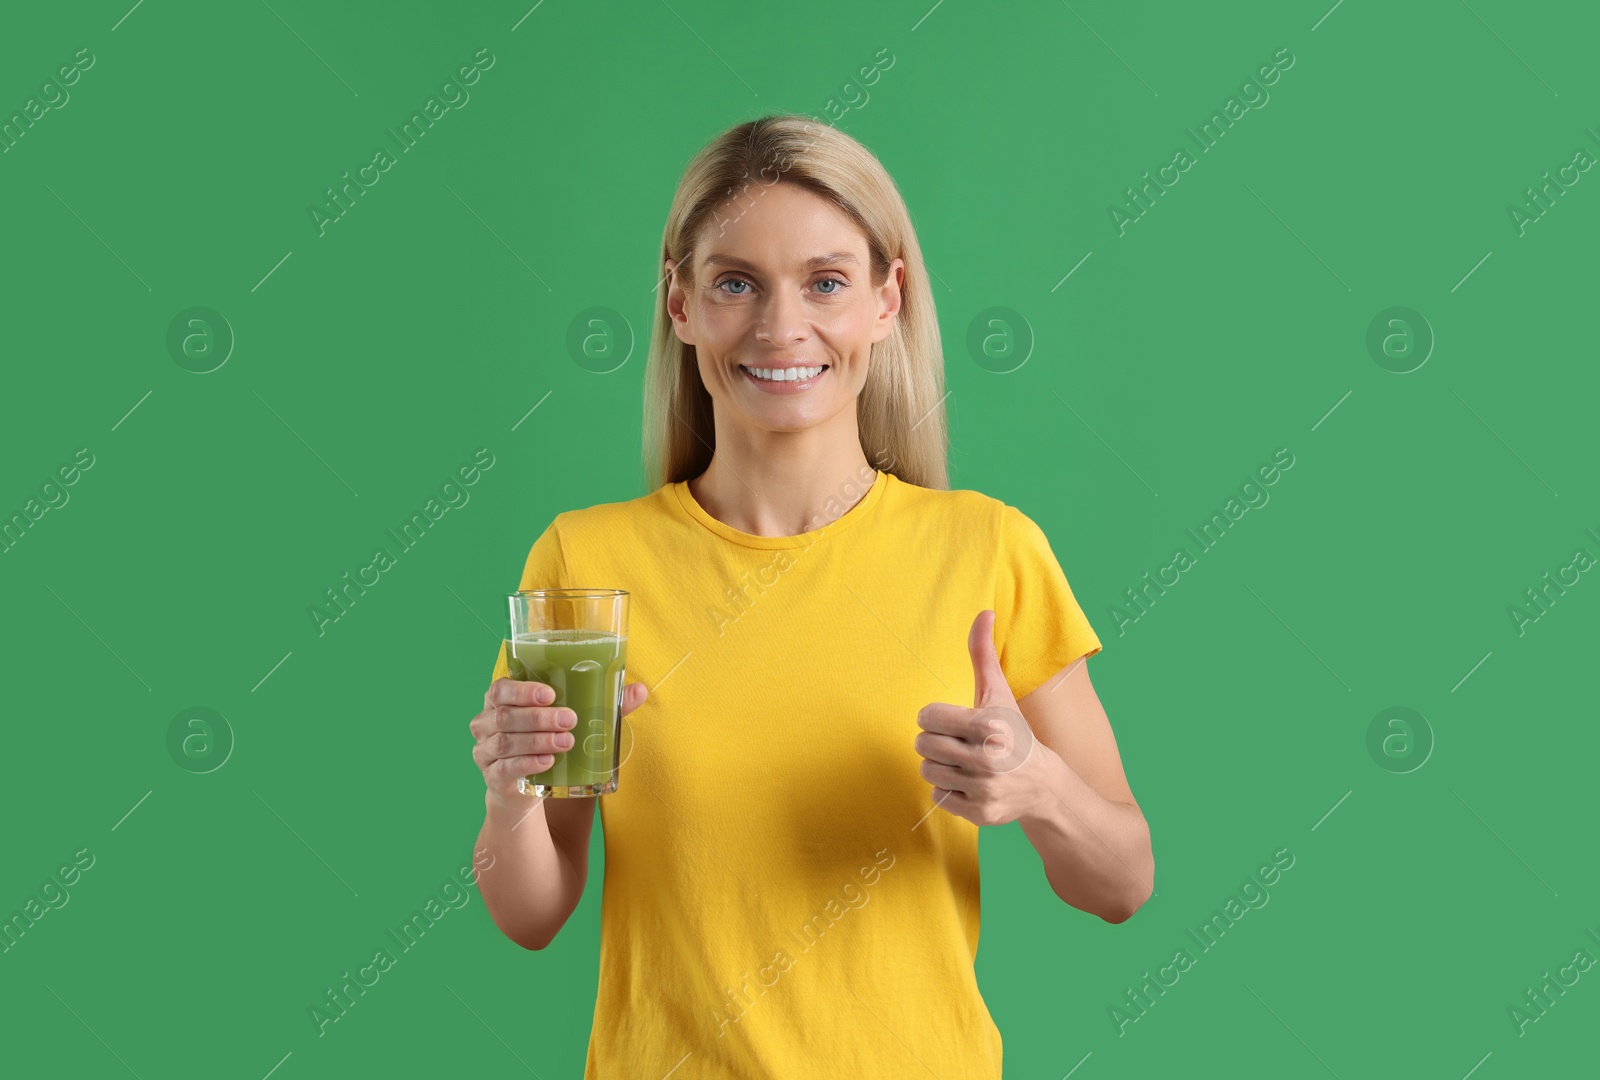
696, 184, 867, 270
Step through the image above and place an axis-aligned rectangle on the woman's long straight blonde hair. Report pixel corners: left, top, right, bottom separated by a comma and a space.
642, 115, 949, 490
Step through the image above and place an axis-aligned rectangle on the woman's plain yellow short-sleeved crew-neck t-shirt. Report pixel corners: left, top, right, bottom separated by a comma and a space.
493, 472, 1101, 1080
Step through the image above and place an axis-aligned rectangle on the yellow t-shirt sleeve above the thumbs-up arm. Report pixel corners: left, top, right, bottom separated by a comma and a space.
994, 506, 1101, 699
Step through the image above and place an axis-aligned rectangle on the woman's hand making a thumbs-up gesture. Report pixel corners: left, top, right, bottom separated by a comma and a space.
917, 610, 1053, 826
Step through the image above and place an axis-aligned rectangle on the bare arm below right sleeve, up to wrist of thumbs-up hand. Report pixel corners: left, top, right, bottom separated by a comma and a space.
1018, 658, 1155, 923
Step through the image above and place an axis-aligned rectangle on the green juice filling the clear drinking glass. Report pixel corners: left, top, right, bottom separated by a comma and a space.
506, 630, 627, 795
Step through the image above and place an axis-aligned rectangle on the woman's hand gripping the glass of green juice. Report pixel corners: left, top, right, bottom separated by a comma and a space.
469, 678, 650, 805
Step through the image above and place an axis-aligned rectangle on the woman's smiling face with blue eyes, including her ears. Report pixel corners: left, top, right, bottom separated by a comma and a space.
666, 182, 904, 430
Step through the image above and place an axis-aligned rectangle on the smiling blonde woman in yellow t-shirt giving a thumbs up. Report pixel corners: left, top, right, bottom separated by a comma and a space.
472, 117, 1154, 1078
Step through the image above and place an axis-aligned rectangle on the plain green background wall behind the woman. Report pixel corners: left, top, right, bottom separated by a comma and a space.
0, 0, 1600, 1080
